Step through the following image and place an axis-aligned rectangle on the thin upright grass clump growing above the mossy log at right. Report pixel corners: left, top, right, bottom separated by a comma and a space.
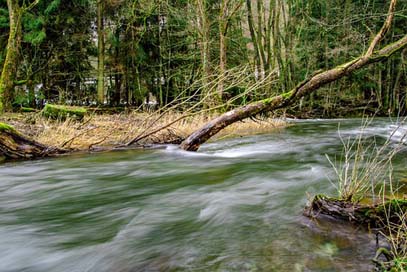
326, 120, 404, 203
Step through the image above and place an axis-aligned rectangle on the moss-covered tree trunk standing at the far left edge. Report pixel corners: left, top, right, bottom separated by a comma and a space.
0, 0, 22, 112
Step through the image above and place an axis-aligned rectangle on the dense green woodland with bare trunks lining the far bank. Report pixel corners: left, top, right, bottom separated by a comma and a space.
0, 0, 407, 117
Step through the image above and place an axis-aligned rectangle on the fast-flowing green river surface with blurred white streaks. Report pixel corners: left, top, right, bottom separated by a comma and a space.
0, 119, 407, 272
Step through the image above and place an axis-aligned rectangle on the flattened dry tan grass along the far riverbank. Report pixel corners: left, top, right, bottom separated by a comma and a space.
0, 112, 286, 149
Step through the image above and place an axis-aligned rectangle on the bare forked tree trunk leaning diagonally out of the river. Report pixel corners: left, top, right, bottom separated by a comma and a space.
180, 0, 407, 151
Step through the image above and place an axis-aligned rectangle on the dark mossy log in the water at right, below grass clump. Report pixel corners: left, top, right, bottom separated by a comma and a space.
304, 195, 407, 228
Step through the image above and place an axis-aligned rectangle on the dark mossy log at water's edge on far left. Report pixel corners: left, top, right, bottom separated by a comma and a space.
0, 123, 67, 161
